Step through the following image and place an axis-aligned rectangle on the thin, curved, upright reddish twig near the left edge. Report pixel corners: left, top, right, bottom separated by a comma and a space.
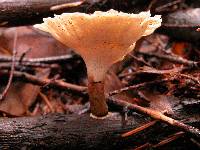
0, 30, 17, 100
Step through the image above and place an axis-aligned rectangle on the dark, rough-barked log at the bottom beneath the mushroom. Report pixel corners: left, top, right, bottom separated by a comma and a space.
0, 114, 150, 149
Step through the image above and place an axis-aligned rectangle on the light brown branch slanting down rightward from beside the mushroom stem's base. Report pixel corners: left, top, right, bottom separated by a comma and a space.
109, 98, 200, 138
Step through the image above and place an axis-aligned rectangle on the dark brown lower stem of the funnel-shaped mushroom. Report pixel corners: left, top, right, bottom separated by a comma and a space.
88, 77, 108, 118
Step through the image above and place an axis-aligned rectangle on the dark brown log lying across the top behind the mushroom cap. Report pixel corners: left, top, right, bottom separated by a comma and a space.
0, 0, 149, 27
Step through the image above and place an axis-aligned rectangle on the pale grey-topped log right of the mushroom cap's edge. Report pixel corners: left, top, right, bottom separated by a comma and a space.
160, 8, 200, 42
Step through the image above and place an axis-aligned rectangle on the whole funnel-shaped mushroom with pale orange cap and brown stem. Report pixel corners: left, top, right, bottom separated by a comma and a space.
34, 9, 162, 118
